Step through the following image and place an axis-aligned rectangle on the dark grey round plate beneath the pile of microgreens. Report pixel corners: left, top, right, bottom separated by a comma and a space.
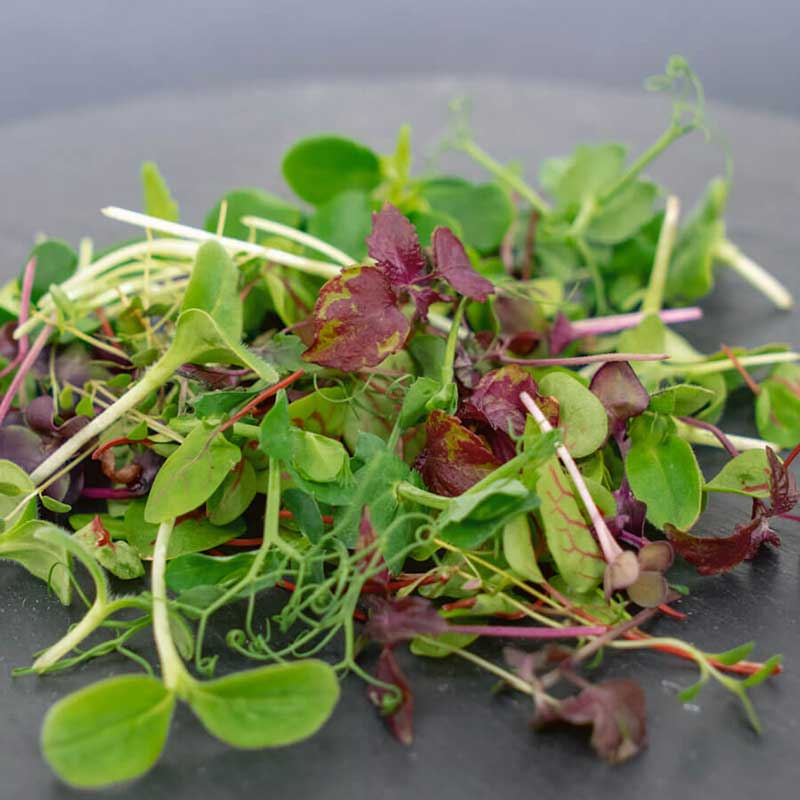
0, 79, 800, 800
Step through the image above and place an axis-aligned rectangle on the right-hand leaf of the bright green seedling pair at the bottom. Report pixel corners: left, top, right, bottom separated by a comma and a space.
187, 659, 339, 749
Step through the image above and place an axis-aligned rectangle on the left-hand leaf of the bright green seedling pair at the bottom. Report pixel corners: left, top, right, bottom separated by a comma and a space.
41, 675, 175, 789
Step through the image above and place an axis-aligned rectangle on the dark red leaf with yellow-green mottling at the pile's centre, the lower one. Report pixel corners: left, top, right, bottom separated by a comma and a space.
414, 410, 500, 497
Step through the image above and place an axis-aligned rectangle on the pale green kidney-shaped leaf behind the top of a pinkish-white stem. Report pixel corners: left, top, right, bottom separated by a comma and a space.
539, 372, 608, 458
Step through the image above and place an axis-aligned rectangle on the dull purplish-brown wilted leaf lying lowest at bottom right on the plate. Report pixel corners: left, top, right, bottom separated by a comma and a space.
534, 678, 647, 764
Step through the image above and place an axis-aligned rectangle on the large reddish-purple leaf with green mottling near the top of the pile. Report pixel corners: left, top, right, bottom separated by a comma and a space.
303, 267, 411, 372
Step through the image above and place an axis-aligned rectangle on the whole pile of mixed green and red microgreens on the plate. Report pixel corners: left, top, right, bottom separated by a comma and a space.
0, 58, 800, 787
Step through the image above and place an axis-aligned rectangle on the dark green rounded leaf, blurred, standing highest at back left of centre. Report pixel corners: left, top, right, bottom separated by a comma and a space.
283, 136, 381, 206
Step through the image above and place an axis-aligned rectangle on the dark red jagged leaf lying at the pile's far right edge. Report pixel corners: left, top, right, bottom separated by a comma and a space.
664, 514, 781, 575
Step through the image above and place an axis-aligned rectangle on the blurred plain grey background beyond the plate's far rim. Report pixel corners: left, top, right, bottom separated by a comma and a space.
0, 0, 800, 123
